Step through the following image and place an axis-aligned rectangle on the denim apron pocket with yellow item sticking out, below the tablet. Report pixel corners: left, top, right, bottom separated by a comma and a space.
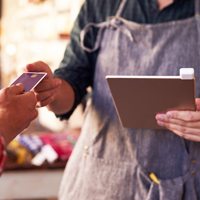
137, 167, 198, 200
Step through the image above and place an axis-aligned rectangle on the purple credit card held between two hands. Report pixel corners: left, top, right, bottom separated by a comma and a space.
11, 72, 47, 92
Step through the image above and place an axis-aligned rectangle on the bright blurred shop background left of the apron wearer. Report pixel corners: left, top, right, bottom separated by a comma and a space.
0, 0, 84, 200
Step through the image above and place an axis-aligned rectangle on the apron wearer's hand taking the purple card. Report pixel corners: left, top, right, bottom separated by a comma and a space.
26, 61, 62, 107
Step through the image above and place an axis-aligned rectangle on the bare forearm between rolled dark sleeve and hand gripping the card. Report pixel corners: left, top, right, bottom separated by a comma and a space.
48, 80, 75, 114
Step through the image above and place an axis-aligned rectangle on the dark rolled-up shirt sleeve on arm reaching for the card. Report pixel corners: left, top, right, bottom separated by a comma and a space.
54, 0, 118, 119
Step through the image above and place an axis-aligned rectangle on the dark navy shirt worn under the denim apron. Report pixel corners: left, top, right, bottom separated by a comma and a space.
55, 0, 195, 119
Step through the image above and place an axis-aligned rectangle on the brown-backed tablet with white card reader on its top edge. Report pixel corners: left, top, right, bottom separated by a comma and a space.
106, 68, 195, 129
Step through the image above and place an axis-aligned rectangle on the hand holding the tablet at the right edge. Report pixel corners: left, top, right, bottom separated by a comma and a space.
156, 99, 200, 142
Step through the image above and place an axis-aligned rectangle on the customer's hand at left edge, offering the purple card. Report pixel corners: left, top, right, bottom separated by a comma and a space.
0, 84, 37, 143
